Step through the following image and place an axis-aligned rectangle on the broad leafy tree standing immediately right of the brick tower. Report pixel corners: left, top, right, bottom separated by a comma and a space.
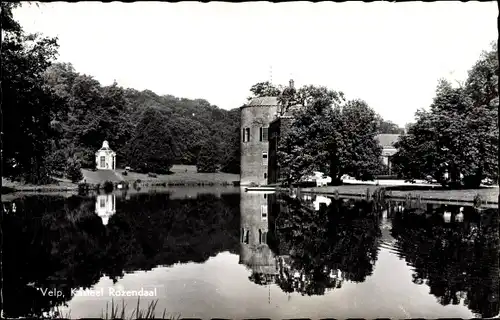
278, 86, 382, 185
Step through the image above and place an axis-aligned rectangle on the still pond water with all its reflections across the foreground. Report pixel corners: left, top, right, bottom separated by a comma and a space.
2, 189, 500, 319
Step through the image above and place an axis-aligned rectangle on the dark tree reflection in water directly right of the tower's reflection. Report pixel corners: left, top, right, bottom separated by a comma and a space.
269, 196, 381, 295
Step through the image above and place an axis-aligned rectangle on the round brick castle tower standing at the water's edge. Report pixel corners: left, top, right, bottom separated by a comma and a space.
240, 97, 278, 186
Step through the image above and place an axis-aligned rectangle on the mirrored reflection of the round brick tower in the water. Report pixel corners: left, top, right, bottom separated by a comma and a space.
240, 192, 277, 275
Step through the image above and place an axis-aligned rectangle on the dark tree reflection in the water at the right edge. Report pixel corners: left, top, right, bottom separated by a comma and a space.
392, 207, 500, 317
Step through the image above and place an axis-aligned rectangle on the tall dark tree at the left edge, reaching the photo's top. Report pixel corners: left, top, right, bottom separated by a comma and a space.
1, 2, 59, 183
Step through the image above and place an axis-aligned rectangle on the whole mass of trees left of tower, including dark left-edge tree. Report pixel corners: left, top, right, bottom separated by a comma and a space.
1, 2, 240, 183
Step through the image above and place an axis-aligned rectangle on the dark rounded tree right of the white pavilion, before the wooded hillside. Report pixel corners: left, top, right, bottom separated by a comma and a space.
127, 109, 175, 174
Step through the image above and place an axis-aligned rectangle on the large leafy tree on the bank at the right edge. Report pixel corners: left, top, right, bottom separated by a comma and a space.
393, 46, 498, 188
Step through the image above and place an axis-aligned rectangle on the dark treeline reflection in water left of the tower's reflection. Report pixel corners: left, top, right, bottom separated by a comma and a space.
2, 194, 239, 317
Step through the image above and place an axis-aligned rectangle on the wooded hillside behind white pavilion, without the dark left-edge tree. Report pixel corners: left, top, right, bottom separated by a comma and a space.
45, 64, 239, 173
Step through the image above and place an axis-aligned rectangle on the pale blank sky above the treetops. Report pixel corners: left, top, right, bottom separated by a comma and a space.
14, 1, 498, 126
